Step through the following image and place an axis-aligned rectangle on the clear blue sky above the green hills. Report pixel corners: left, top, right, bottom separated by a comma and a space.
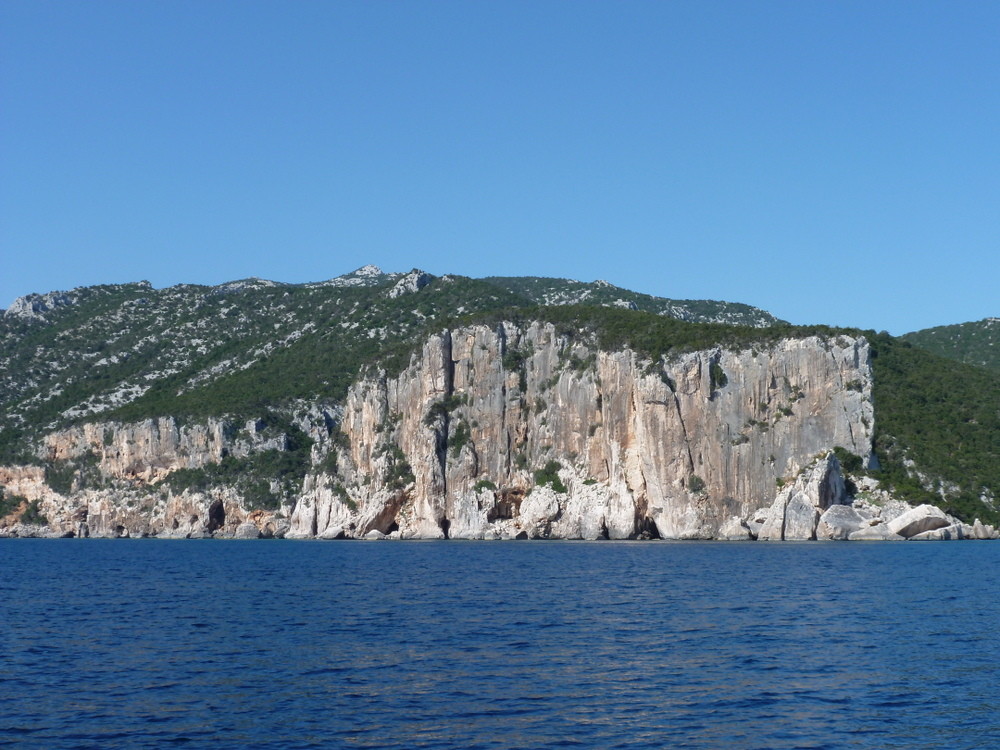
0, 0, 1000, 334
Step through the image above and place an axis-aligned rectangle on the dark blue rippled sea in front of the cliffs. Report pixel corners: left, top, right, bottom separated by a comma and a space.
0, 540, 1000, 749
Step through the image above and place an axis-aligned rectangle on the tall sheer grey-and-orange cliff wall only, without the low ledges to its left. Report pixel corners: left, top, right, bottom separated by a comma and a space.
290, 324, 873, 539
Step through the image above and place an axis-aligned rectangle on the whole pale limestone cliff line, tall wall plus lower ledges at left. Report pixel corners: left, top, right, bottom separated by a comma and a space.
0, 323, 874, 539
